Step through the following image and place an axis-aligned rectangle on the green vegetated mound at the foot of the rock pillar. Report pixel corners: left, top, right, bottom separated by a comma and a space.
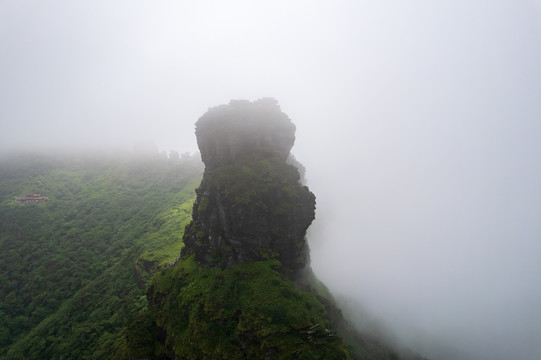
125, 256, 349, 359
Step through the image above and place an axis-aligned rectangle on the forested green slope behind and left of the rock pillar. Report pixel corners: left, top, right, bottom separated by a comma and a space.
0, 154, 202, 359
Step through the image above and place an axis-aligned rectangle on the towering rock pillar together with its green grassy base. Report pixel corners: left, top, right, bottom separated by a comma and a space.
124, 99, 414, 360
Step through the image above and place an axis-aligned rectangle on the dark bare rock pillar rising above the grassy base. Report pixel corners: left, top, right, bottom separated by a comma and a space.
182, 99, 315, 277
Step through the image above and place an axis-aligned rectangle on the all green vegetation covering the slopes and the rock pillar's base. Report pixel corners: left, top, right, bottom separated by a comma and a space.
0, 150, 404, 360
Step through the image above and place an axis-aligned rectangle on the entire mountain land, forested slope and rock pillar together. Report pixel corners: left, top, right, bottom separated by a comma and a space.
0, 99, 426, 360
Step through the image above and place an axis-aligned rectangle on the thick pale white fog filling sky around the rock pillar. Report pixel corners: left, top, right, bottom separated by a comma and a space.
0, 0, 541, 360
